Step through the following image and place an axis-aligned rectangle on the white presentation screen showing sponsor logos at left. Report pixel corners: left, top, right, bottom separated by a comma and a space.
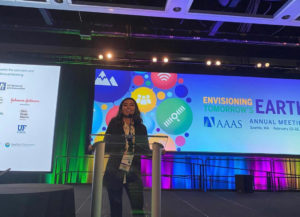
0, 63, 60, 172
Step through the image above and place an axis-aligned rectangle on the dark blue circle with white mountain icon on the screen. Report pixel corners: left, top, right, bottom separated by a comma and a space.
94, 69, 131, 102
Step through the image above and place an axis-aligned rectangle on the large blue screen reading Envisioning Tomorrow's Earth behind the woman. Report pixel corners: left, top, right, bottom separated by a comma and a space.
92, 69, 300, 155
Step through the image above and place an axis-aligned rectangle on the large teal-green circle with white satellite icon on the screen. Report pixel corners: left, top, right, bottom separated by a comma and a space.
156, 98, 193, 135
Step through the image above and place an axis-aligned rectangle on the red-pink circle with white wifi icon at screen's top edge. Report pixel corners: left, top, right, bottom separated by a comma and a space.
151, 72, 177, 90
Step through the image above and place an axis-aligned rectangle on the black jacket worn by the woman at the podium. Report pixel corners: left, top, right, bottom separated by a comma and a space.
104, 118, 150, 189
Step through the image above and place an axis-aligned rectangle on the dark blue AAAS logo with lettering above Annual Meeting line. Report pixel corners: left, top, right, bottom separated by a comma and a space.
204, 116, 243, 129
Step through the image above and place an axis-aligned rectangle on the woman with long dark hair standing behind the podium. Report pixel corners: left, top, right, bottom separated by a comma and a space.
103, 98, 150, 217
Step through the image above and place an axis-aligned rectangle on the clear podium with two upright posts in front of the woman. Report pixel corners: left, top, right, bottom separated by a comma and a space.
91, 134, 168, 217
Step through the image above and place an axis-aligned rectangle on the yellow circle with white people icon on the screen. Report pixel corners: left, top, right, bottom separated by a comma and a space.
131, 87, 156, 113
